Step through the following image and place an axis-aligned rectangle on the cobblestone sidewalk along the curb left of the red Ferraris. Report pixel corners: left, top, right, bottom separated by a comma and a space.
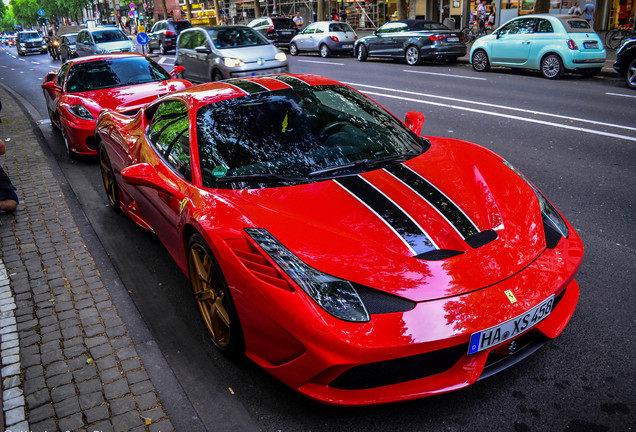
0, 87, 174, 432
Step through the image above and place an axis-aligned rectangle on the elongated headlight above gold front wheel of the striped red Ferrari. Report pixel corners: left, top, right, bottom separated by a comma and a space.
245, 228, 369, 322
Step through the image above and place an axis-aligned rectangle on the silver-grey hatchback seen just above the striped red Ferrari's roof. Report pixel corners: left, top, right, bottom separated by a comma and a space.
175, 25, 289, 82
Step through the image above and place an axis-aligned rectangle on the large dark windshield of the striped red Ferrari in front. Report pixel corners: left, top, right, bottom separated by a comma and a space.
197, 86, 424, 188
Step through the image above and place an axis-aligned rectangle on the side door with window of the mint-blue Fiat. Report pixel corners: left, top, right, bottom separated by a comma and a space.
491, 18, 535, 67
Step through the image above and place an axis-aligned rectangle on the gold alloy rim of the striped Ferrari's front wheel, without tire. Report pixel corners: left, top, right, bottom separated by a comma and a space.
188, 243, 231, 349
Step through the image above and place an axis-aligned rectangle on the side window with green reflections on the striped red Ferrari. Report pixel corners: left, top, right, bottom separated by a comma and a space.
147, 101, 192, 181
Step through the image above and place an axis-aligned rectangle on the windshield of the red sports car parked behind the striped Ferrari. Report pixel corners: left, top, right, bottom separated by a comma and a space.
66, 56, 170, 93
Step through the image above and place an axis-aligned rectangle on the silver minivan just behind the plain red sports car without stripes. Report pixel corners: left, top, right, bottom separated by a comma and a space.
75, 26, 137, 57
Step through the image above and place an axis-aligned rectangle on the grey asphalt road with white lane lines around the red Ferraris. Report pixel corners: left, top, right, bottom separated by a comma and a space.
0, 44, 636, 432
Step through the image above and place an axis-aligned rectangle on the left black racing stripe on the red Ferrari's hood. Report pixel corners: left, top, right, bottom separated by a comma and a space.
334, 176, 436, 255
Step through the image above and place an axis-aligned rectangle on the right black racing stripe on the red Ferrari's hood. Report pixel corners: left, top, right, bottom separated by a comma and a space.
386, 164, 479, 238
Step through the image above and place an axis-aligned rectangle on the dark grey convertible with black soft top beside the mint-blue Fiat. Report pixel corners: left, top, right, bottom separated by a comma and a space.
354, 20, 466, 66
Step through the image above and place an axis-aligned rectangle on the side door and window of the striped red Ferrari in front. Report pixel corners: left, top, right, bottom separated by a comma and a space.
132, 100, 192, 251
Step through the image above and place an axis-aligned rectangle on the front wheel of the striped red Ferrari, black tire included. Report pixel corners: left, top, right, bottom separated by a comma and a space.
188, 233, 245, 358
